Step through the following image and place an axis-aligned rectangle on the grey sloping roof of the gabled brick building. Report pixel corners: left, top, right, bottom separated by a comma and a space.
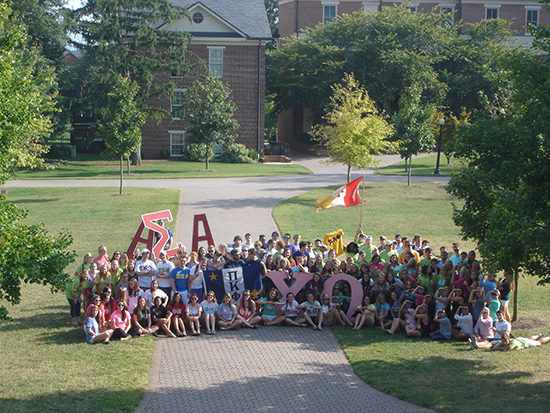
170, 0, 272, 39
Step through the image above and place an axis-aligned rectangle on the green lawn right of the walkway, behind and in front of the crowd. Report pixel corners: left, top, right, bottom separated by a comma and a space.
273, 184, 550, 412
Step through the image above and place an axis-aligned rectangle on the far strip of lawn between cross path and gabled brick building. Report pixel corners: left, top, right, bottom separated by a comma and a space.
12, 157, 311, 179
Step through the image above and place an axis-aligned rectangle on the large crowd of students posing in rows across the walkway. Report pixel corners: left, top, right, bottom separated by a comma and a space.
66, 227, 550, 350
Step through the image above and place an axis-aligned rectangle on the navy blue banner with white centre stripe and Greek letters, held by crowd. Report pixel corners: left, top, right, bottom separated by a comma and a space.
204, 263, 262, 303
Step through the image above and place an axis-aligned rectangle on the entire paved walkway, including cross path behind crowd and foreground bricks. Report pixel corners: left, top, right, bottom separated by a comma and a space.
5, 154, 447, 412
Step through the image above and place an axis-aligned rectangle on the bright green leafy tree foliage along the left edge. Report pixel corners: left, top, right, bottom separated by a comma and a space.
0, 3, 75, 319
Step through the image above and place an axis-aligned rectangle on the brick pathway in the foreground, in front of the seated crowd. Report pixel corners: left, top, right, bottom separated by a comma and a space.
136, 327, 434, 413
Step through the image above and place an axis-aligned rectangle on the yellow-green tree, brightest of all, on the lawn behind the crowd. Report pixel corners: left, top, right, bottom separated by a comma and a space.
312, 75, 392, 182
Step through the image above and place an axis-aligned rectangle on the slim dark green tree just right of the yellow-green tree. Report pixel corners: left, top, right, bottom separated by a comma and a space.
392, 85, 436, 186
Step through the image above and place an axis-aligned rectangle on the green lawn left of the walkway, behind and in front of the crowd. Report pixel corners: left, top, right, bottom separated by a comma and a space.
0, 188, 179, 412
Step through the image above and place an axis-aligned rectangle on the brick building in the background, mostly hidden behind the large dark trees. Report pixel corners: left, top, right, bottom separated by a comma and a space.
278, 0, 550, 145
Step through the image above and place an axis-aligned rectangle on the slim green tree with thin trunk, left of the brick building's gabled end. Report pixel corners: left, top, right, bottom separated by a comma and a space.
98, 76, 145, 195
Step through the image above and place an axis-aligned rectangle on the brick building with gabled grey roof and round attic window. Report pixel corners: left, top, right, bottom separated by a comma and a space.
142, 0, 272, 158
